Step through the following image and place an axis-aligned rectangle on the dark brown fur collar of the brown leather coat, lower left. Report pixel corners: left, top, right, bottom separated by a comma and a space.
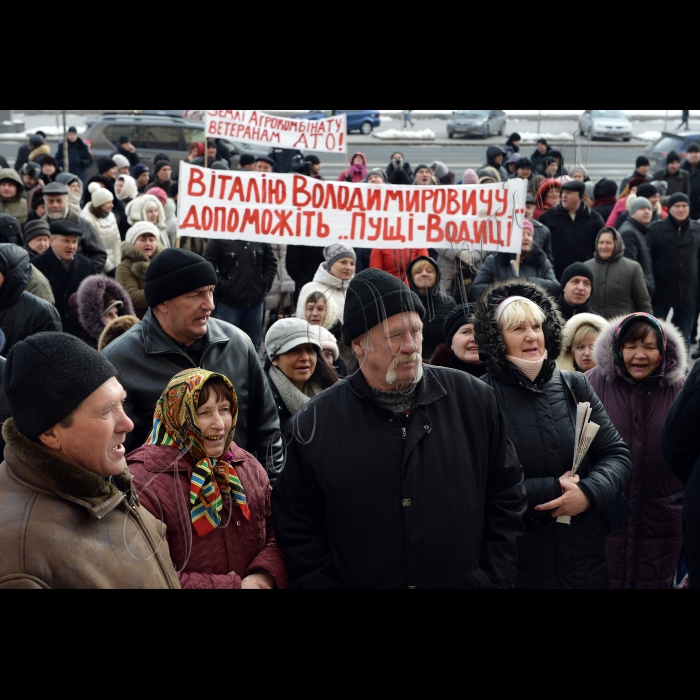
2, 418, 132, 517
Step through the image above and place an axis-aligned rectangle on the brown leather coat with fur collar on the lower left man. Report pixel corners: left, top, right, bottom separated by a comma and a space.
0, 419, 180, 589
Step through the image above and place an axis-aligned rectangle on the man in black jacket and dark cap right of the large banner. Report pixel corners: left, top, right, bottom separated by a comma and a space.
539, 180, 605, 279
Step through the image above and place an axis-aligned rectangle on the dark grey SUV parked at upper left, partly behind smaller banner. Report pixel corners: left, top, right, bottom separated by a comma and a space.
83, 114, 267, 176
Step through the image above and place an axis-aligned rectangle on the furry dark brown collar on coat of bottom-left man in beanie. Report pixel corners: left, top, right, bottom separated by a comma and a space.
2, 418, 133, 520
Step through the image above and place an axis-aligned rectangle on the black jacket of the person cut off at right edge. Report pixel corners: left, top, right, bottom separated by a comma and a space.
661, 362, 700, 591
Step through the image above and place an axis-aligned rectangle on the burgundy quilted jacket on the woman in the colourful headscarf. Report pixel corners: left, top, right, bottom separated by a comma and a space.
126, 445, 289, 590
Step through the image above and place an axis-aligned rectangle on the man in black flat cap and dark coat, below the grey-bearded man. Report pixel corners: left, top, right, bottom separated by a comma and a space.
32, 219, 95, 338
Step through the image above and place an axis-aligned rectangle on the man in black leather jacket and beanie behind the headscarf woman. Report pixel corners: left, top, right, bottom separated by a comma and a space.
103, 248, 283, 482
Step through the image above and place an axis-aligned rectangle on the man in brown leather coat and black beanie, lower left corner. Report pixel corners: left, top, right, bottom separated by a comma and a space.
0, 333, 180, 590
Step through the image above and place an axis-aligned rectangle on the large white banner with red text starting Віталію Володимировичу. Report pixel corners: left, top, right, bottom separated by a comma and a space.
178, 163, 527, 253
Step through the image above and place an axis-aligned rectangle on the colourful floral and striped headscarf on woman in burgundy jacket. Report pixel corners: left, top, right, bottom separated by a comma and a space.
146, 369, 250, 537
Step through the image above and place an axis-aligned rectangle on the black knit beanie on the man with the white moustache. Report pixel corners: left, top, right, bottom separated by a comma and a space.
342, 268, 425, 347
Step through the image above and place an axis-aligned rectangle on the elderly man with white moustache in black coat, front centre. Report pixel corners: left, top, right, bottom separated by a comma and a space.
272, 270, 527, 589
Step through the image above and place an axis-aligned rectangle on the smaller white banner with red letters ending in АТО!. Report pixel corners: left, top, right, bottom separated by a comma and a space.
206, 109, 348, 153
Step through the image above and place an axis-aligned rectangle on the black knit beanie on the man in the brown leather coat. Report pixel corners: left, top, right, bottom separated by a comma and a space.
3, 333, 117, 441
